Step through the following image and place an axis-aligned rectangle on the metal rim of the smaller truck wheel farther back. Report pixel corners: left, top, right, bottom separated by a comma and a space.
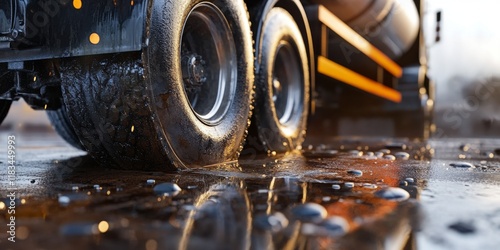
272, 41, 303, 127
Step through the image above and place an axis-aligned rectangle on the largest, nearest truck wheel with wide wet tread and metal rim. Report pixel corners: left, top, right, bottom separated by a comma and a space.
63, 0, 253, 169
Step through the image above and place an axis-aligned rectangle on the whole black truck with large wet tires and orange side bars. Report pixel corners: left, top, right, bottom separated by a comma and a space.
0, 0, 433, 169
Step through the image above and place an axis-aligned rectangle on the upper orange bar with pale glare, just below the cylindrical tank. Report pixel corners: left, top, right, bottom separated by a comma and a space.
318, 6, 403, 78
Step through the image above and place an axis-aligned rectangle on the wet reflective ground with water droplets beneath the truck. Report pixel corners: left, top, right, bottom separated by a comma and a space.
0, 131, 500, 250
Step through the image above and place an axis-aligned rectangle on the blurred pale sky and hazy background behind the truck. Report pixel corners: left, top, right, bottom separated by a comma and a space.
0, 0, 500, 138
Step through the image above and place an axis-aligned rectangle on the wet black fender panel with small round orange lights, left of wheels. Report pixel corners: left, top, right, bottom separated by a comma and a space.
0, 0, 148, 62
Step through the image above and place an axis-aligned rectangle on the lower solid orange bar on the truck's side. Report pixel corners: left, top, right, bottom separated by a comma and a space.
318, 56, 401, 103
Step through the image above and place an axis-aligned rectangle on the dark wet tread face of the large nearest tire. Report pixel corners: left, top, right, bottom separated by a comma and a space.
62, 55, 167, 168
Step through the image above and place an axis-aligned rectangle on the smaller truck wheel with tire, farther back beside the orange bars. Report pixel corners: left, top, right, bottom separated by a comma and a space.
252, 7, 310, 152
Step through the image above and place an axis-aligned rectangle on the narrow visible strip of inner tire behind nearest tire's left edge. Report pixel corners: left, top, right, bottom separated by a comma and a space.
47, 104, 85, 150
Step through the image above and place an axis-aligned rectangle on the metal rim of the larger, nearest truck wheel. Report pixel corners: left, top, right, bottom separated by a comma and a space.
181, 3, 237, 126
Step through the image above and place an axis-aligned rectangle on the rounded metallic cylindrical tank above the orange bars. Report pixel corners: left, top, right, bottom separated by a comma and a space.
311, 0, 420, 60
